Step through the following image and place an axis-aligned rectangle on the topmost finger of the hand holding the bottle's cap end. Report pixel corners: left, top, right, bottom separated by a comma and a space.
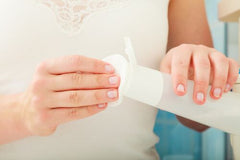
38, 55, 114, 75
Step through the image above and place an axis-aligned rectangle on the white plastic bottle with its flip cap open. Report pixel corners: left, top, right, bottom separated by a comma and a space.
104, 39, 240, 135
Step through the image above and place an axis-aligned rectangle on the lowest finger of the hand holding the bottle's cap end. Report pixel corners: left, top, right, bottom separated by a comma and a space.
50, 103, 107, 125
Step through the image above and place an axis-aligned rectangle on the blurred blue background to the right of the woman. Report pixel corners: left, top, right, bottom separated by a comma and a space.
154, 0, 238, 160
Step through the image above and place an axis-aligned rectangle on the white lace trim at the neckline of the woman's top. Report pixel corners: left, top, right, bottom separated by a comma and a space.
38, 0, 128, 35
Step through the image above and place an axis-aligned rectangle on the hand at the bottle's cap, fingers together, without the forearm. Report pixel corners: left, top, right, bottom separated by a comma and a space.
20, 55, 120, 136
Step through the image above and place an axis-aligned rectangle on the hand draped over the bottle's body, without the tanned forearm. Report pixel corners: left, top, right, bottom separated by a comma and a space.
160, 44, 239, 105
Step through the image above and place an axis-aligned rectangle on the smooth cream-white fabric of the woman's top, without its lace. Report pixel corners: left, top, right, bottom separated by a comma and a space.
0, 0, 168, 160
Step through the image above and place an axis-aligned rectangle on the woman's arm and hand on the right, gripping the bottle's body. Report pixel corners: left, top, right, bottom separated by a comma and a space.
160, 0, 239, 132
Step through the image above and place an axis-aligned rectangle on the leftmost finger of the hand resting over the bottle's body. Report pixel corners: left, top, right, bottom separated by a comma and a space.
171, 47, 192, 96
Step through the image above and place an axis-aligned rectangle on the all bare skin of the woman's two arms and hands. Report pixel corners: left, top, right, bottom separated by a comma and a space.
0, 0, 238, 144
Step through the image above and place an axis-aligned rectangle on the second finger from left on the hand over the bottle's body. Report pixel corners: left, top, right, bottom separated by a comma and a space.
193, 50, 210, 105
